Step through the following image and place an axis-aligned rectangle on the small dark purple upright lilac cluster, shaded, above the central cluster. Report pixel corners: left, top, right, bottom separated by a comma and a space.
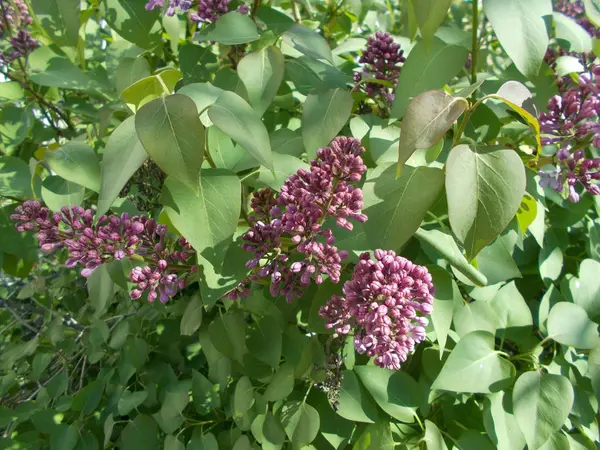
354, 31, 406, 103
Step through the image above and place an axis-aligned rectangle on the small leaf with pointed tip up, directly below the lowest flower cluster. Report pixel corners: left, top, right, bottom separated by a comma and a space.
337, 367, 378, 423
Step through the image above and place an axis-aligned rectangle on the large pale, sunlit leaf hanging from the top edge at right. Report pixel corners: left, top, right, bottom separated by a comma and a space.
483, 0, 552, 77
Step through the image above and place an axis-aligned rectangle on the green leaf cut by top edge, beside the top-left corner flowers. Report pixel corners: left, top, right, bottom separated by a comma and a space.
31, 0, 81, 47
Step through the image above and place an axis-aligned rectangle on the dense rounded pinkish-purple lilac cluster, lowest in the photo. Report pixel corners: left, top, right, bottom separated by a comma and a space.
319, 250, 434, 370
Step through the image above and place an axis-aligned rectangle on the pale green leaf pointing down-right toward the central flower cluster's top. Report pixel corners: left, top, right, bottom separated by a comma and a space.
208, 91, 273, 170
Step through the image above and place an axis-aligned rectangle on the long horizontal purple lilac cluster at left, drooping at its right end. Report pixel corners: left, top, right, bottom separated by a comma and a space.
10, 200, 195, 302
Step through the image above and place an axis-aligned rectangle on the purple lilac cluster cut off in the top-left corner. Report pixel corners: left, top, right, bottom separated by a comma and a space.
0, 0, 38, 64
